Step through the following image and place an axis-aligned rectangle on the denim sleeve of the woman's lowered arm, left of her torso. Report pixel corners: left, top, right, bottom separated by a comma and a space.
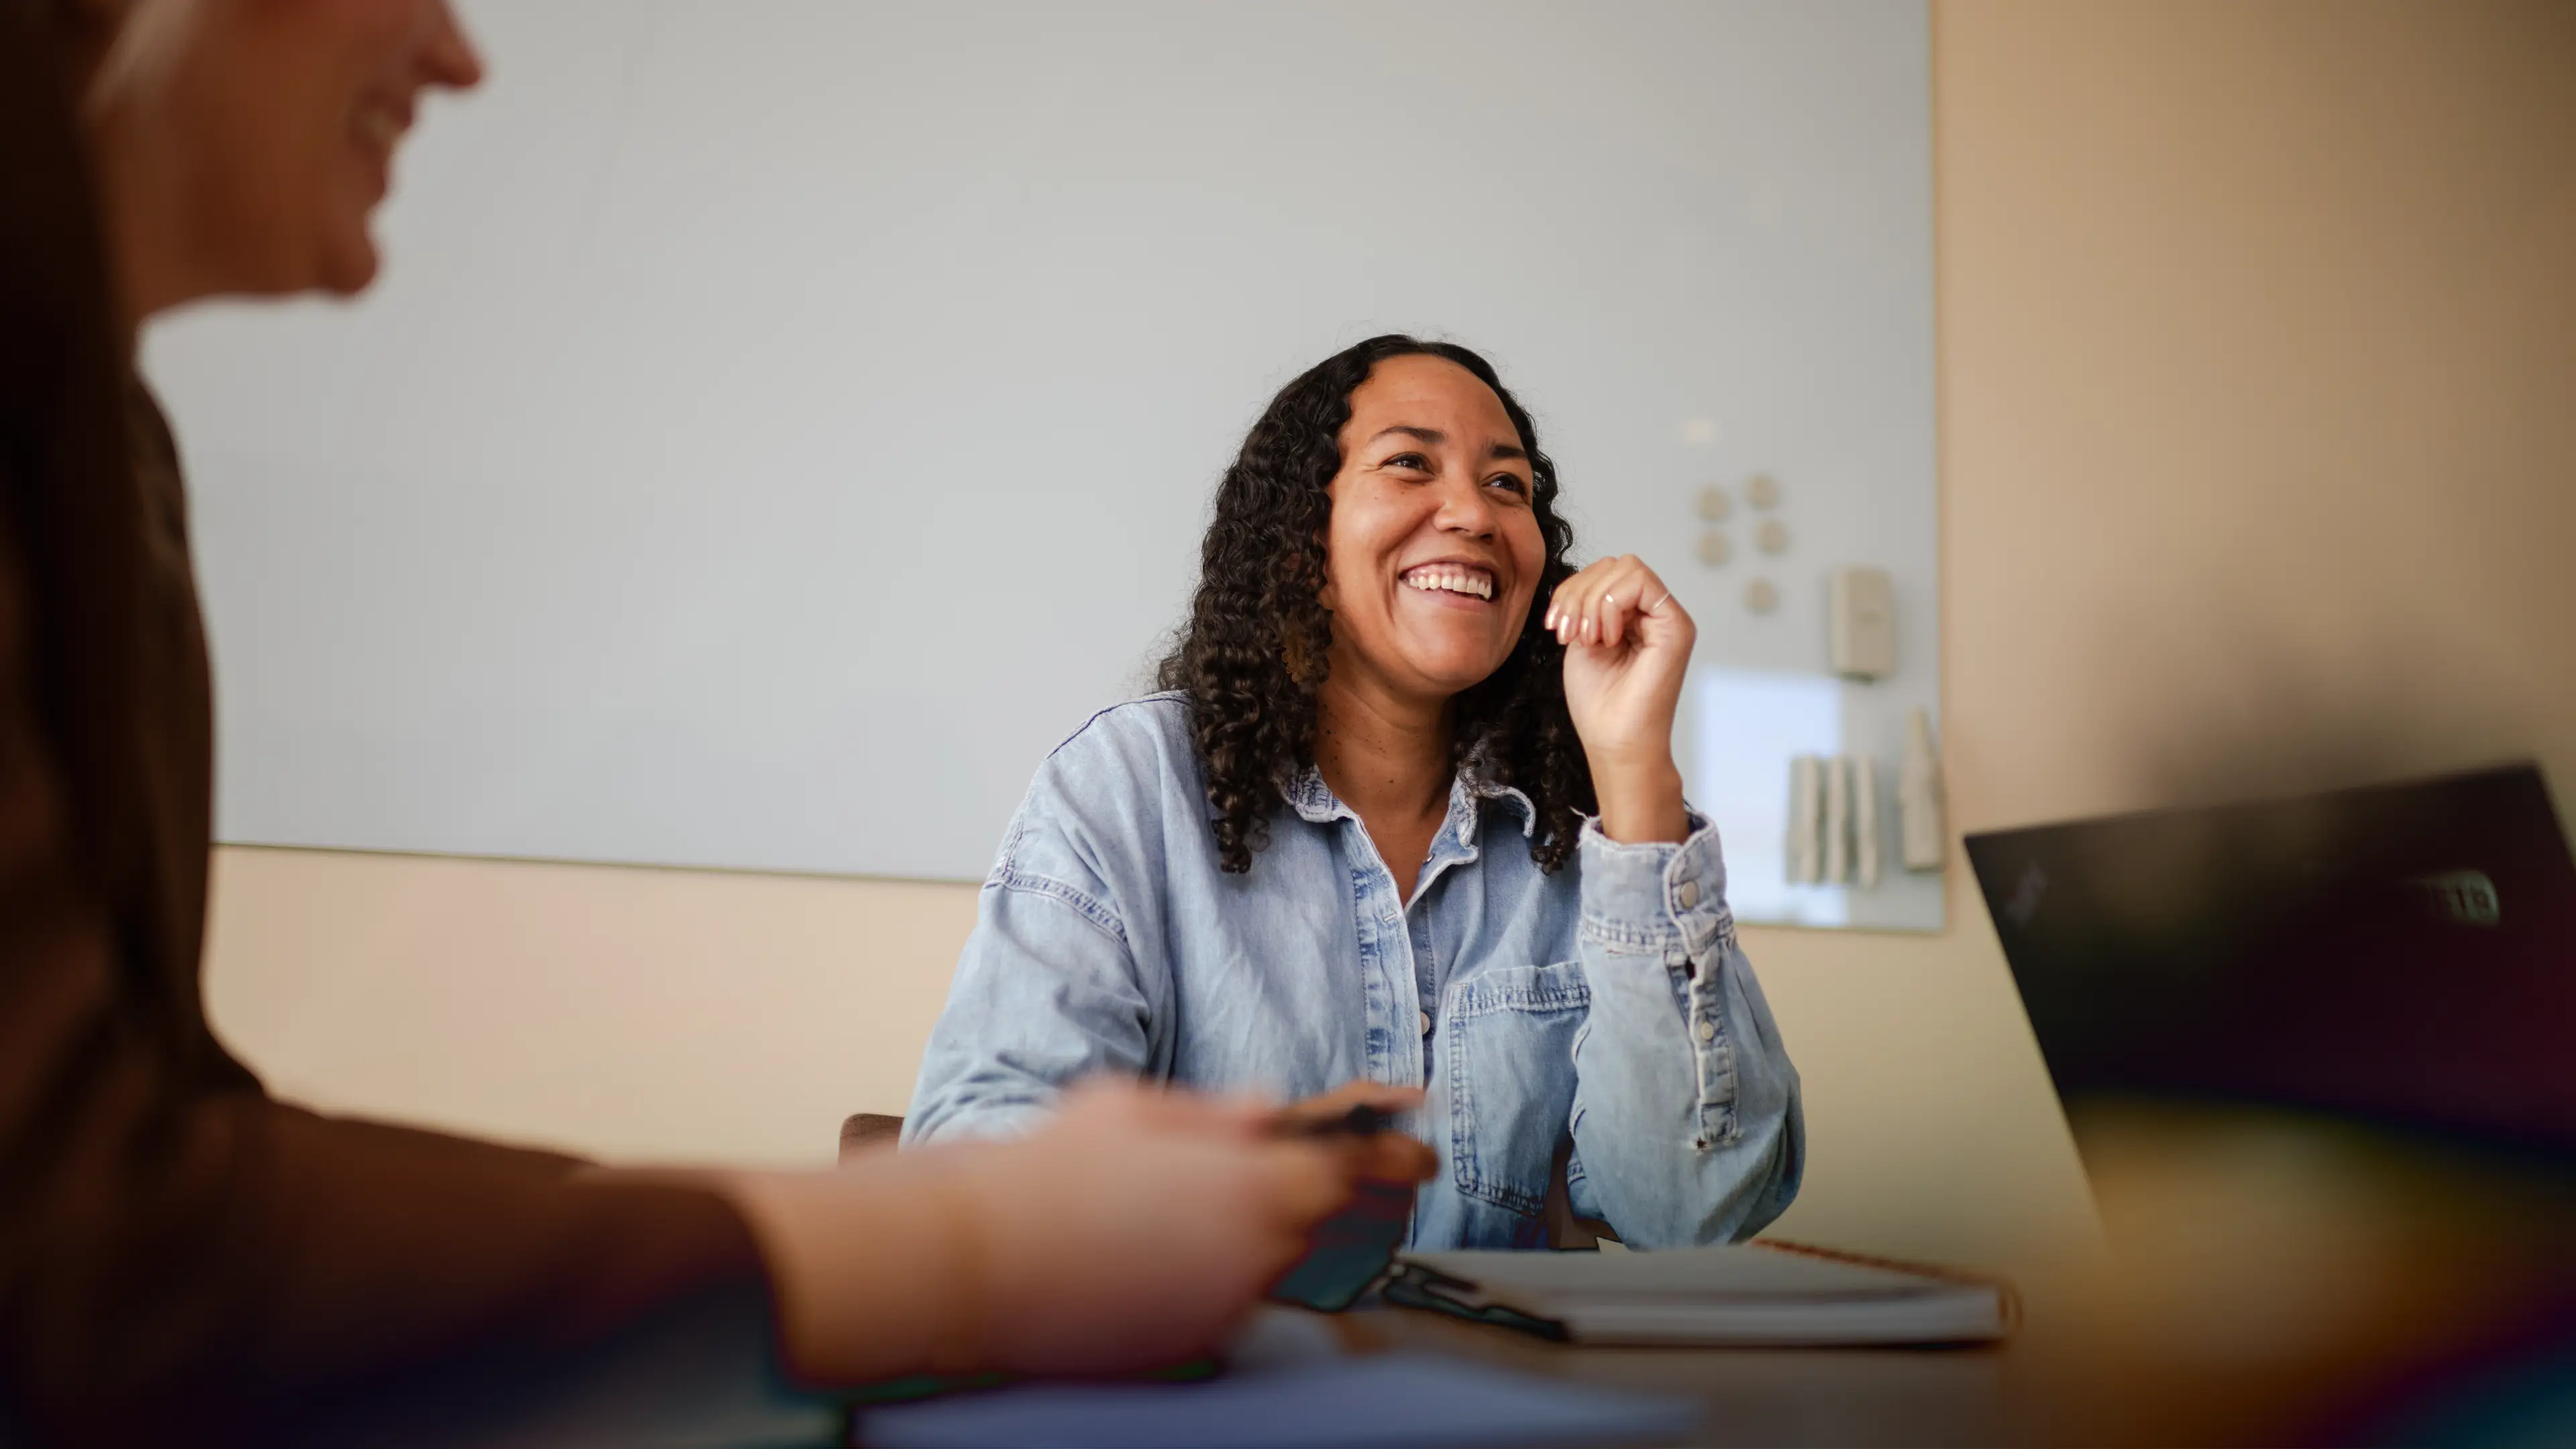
904, 797, 1157, 1144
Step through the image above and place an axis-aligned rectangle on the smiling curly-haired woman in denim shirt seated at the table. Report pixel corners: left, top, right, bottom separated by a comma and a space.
907, 335, 1803, 1248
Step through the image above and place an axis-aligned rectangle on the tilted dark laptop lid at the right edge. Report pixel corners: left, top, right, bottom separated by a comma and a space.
1968, 765, 2576, 1158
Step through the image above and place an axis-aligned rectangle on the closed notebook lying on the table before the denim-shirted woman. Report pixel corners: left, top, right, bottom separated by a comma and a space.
1386, 1227, 2020, 1348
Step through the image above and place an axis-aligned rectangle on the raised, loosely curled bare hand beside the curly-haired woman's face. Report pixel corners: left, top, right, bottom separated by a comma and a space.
1546, 554, 1700, 843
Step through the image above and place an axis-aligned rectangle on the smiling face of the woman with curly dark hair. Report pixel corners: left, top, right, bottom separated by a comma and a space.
1324, 356, 1548, 701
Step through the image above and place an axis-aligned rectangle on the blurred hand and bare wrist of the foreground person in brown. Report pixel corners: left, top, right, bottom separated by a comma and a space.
727, 1083, 1373, 1382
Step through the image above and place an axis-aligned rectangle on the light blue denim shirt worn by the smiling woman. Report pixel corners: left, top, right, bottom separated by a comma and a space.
904, 694, 1806, 1248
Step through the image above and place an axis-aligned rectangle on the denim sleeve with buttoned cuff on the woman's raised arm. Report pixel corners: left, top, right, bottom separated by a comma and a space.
1566, 815, 1806, 1248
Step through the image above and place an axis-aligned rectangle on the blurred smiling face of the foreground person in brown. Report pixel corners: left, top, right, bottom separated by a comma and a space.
90, 0, 482, 294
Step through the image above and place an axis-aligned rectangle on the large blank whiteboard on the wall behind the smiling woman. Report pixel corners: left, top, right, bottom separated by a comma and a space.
144, 0, 1940, 926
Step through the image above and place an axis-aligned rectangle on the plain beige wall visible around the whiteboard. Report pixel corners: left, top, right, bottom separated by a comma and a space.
209, 0, 2576, 1260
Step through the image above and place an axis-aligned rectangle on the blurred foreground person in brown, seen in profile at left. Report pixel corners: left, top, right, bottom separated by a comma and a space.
0, 0, 1401, 1441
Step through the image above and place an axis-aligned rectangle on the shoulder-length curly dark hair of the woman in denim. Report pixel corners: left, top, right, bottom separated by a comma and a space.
1157, 333, 1595, 874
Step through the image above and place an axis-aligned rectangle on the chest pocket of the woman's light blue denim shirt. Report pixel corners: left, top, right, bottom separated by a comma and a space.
1442, 962, 1592, 1217
